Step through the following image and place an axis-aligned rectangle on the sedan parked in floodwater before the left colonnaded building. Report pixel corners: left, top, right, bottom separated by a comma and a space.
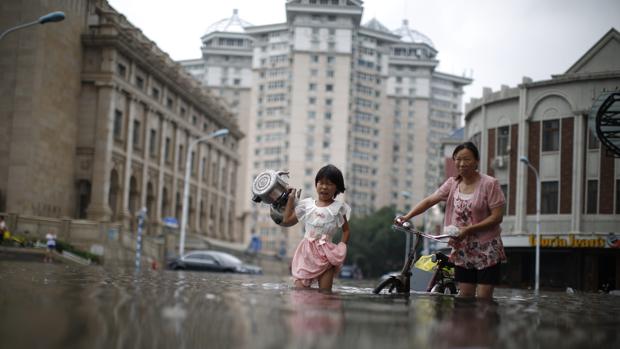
168, 251, 263, 274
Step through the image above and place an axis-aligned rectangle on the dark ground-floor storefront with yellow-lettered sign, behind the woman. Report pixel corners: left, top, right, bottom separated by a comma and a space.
502, 233, 620, 291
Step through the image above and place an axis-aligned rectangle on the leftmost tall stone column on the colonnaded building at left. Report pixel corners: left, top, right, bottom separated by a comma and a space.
87, 83, 116, 221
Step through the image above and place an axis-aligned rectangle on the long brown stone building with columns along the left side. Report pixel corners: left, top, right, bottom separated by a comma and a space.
0, 0, 243, 241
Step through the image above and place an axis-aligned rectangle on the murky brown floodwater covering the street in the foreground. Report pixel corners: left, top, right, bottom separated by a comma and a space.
0, 260, 620, 348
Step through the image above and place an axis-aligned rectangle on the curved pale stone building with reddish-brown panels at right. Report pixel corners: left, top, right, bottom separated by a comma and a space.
465, 29, 620, 290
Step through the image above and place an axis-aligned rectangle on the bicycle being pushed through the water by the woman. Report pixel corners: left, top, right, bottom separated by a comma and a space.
372, 222, 457, 295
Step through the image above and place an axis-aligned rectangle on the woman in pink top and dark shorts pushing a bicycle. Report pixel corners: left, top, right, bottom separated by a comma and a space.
395, 142, 506, 298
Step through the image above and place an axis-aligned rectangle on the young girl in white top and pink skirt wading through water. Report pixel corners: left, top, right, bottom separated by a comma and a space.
282, 165, 351, 291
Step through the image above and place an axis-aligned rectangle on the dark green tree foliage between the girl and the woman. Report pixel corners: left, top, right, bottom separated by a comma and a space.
334, 207, 405, 278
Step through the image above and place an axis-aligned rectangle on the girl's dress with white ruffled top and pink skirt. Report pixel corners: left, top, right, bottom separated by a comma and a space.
291, 198, 351, 287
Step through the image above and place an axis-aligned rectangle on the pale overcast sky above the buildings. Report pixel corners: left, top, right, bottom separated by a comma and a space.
108, 0, 620, 101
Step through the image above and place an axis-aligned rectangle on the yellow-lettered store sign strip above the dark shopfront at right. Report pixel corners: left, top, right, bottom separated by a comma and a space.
528, 233, 620, 248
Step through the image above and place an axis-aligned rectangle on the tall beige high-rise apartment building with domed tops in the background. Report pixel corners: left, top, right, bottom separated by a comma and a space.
181, 0, 471, 254
